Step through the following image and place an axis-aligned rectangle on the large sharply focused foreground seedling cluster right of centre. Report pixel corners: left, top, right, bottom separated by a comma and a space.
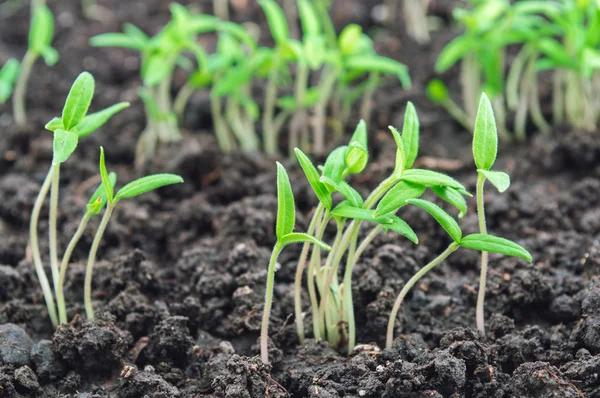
261, 94, 531, 362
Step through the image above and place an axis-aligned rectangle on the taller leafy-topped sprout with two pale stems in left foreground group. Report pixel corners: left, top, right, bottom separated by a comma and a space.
29, 72, 129, 327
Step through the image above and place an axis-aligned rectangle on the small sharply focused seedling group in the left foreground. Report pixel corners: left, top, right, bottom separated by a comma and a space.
29, 72, 183, 327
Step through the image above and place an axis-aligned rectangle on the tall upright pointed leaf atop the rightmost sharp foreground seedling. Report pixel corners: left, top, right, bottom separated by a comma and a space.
473, 93, 498, 170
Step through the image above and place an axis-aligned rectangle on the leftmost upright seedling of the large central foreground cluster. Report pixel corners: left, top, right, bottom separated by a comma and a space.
260, 162, 331, 363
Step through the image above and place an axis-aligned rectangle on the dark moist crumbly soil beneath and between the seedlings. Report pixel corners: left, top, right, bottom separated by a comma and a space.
0, 0, 600, 398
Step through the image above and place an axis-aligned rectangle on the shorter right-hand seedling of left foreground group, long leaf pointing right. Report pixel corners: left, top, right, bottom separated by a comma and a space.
83, 147, 183, 320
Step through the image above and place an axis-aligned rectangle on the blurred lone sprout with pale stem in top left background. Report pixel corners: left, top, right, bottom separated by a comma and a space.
13, 5, 58, 126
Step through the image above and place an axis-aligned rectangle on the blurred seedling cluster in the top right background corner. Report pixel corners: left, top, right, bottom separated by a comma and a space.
428, 0, 600, 140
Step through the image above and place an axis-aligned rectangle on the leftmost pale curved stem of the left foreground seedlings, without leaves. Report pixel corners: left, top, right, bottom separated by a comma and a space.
29, 165, 58, 327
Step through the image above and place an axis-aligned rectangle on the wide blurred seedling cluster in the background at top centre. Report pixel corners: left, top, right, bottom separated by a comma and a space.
90, 0, 410, 162
